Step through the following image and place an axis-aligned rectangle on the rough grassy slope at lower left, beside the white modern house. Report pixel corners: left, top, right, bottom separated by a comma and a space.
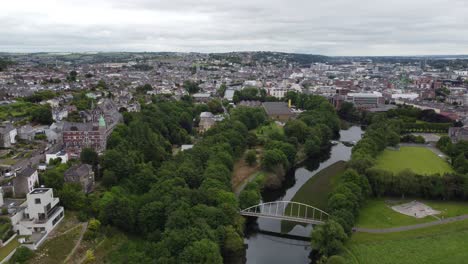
31, 226, 81, 264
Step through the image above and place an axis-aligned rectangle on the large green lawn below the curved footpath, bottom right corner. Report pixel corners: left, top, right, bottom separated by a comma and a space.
345, 220, 468, 264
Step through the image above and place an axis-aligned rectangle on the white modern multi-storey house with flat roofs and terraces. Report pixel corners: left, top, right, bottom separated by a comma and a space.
8, 188, 64, 249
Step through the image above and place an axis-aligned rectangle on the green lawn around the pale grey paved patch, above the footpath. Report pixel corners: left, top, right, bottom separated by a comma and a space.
356, 198, 468, 228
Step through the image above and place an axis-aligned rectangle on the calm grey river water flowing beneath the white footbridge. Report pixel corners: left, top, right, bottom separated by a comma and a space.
245, 126, 363, 264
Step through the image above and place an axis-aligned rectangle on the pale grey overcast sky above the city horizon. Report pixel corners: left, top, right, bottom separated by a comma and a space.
0, 0, 468, 55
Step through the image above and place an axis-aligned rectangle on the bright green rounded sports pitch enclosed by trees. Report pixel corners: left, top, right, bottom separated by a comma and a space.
375, 147, 453, 175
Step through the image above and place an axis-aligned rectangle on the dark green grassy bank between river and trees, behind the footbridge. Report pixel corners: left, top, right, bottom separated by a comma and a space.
281, 161, 346, 233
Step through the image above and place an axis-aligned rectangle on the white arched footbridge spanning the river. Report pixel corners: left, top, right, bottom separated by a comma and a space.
241, 201, 329, 222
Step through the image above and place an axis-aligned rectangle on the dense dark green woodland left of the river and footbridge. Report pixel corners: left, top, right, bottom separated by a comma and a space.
95, 97, 266, 263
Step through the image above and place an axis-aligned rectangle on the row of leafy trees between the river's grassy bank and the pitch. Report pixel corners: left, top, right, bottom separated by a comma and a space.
311, 114, 401, 260
